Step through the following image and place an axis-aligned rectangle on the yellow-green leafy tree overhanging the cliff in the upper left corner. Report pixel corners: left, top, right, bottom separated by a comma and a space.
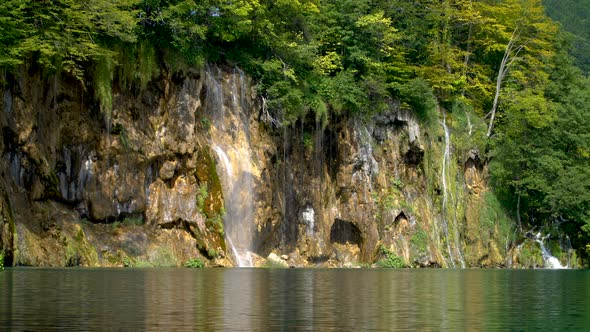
0, 0, 137, 78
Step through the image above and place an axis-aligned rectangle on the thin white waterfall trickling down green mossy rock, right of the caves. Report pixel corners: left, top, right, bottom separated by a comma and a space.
440, 110, 465, 268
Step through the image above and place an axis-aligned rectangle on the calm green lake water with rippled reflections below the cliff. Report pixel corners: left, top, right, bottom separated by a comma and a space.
0, 268, 590, 331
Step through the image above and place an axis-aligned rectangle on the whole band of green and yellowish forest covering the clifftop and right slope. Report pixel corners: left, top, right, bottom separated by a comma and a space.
0, 0, 590, 258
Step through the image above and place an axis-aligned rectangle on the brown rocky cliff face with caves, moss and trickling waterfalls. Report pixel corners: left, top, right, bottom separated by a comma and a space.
0, 67, 524, 267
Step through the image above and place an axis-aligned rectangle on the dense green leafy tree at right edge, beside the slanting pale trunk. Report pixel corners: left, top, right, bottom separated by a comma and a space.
491, 42, 590, 252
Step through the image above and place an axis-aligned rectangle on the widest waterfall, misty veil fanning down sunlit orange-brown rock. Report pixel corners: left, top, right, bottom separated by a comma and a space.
205, 67, 254, 267
